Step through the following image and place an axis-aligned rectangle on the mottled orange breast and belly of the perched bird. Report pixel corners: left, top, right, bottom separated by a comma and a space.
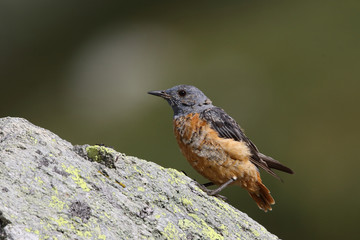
174, 113, 257, 187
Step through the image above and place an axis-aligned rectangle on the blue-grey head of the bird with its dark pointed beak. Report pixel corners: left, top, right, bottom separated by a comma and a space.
148, 85, 213, 118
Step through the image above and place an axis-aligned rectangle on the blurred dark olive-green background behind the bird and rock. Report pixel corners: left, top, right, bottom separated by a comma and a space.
0, 0, 360, 239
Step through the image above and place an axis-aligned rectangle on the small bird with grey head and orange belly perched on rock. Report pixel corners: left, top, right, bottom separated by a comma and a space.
148, 85, 294, 212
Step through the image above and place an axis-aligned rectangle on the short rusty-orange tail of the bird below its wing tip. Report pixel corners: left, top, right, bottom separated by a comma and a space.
249, 174, 275, 212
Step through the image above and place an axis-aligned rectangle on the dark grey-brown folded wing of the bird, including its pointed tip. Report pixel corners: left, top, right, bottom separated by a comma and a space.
200, 107, 293, 180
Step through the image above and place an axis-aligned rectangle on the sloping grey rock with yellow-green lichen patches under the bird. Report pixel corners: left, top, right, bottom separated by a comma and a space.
0, 117, 278, 240
